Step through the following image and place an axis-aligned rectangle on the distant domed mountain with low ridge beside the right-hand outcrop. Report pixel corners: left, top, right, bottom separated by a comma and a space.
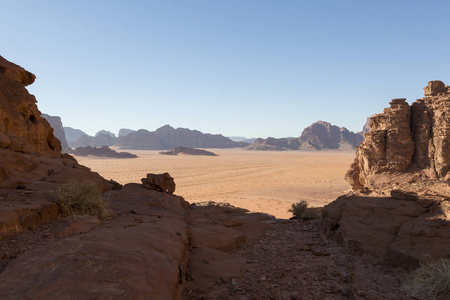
246, 121, 363, 150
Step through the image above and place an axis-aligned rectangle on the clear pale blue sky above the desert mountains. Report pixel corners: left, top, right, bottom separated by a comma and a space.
0, 0, 450, 138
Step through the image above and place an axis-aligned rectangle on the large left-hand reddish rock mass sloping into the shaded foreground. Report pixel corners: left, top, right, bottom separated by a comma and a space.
0, 58, 278, 299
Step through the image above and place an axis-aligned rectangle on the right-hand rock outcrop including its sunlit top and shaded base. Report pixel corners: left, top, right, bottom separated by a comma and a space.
321, 81, 450, 268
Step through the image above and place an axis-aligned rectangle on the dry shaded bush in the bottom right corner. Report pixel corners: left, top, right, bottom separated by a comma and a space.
402, 258, 450, 300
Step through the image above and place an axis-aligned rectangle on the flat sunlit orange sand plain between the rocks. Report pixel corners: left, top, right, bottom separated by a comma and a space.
76, 149, 355, 218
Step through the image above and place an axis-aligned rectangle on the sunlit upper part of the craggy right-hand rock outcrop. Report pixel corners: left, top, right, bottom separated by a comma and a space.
346, 81, 450, 189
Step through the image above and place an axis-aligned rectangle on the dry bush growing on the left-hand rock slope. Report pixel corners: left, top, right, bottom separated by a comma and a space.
50, 180, 109, 219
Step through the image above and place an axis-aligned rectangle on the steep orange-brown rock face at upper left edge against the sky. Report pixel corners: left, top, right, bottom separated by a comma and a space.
0, 56, 61, 157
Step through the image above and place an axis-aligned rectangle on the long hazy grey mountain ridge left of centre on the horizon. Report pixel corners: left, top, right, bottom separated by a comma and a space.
116, 125, 248, 150
